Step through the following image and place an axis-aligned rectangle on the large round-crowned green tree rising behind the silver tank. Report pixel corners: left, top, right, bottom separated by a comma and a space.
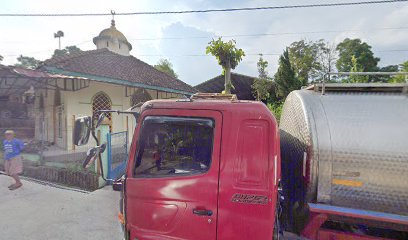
336, 38, 380, 72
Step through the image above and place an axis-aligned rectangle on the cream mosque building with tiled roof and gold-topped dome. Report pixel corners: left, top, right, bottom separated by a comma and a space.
35, 21, 196, 150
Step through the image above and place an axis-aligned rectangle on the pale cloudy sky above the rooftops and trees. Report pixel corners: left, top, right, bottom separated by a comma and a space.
0, 0, 408, 86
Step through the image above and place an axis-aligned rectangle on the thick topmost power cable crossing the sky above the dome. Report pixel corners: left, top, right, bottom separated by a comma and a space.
0, 0, 408, 17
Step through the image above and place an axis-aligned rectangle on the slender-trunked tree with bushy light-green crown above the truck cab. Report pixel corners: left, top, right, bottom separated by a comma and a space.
205, 37, 245, 94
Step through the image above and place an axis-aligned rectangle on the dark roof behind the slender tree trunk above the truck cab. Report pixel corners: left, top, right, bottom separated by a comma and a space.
195, 73, 255, 100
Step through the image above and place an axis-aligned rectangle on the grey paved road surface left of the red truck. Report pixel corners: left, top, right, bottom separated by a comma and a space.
0, 175, 122, 240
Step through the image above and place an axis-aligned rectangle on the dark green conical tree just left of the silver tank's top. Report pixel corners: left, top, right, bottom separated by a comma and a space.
274, 48, 302, 99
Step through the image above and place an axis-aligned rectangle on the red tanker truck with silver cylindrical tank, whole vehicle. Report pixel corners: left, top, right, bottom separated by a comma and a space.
74, 83, 408, 240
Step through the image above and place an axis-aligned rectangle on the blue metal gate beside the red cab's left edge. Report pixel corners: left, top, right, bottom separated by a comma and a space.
107, 131, 128, 179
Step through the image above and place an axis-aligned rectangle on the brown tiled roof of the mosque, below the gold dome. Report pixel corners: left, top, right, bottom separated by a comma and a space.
40, 49, 197, 93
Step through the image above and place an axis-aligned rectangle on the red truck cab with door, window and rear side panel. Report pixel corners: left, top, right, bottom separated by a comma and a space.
123, 98, 280, 240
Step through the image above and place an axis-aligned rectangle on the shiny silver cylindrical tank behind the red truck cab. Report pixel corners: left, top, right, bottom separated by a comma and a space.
280, 84, 408, 239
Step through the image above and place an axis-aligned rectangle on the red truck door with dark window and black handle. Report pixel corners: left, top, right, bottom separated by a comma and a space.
125, 109, 222, 240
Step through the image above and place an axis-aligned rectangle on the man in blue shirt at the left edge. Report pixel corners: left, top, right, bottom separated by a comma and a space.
3, 130, 24, 190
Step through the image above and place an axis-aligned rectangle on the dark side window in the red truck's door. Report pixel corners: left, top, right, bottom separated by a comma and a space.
135, 116, 214, 177
